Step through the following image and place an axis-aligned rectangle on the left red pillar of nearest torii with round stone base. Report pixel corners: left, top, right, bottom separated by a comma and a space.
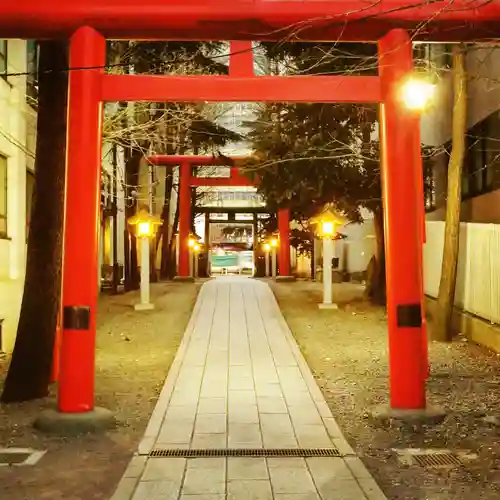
35, 26, 114, 434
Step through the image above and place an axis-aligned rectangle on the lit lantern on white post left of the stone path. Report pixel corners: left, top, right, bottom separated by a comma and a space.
128, 209, 162, 311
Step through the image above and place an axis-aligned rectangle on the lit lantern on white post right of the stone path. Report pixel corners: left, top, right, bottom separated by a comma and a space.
311, 210, 344, 309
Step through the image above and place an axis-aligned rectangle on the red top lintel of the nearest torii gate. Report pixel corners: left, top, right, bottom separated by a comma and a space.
0, 0, 500, 42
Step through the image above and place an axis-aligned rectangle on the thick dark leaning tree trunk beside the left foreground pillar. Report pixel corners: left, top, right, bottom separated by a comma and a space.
1, 40, 68, 403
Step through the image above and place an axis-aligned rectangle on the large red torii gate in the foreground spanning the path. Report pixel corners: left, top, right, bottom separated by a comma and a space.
0, 0, 500, 428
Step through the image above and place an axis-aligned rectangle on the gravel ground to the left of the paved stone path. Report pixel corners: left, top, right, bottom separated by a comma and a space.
0, 283, 199, 500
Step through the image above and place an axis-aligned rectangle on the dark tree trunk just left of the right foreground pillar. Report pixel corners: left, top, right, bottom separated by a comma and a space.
366, 209, 386, 305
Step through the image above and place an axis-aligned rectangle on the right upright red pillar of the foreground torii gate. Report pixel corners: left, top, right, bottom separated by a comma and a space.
379, 29, 439, 417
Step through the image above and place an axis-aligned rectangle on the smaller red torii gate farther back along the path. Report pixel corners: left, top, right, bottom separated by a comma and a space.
146, 155, 291, 278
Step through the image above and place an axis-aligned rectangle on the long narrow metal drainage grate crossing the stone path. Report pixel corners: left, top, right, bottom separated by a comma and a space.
149, 448, 341, 458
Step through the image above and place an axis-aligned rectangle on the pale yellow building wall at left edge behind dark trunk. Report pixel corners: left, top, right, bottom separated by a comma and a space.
0, 40, 36, 352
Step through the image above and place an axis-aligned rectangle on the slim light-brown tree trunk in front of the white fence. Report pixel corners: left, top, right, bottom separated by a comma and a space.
432, 47, 467, 342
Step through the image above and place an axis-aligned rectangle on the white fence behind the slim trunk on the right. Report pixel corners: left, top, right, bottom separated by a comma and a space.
424, 221, 500, 324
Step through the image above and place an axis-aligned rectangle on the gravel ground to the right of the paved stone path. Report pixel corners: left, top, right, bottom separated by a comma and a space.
272, 281, 500, 500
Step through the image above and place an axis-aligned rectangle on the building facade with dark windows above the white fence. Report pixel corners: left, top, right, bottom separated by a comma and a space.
421, 45, 500, 224
